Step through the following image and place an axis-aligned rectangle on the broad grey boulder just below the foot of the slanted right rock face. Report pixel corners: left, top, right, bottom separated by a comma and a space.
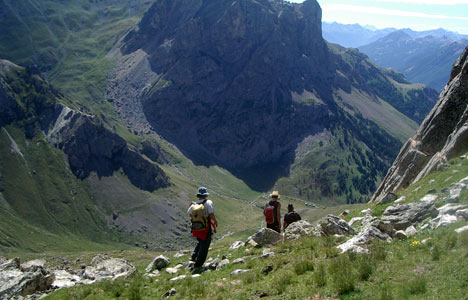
382, 201, 438, 230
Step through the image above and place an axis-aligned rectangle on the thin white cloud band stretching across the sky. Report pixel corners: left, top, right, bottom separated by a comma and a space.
322, 0, 468, 20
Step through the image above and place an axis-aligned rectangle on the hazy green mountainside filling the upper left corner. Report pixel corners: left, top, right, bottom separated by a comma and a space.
0, 0, 151, 137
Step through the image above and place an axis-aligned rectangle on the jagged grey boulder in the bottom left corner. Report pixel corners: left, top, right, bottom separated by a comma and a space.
0, 258, 55, 299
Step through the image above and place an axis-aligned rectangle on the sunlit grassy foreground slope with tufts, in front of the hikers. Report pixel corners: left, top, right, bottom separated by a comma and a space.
42, 152, 468, 300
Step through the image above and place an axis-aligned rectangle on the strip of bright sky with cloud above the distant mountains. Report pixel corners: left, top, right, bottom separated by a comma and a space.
289, 0, 468, 34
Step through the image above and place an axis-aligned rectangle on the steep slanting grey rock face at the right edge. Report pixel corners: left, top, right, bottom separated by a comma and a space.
372, 48, 468, 201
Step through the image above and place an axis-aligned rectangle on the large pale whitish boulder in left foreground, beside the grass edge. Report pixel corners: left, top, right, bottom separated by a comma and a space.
83, 256, 136, 281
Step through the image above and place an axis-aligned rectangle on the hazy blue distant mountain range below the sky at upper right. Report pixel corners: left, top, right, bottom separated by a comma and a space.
322, 23, 468, 91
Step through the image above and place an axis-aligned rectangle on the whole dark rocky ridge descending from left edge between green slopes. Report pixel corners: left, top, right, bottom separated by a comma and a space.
0, 60, 169, 191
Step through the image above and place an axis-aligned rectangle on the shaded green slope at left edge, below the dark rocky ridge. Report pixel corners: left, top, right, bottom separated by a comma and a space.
0, 126, 130, 253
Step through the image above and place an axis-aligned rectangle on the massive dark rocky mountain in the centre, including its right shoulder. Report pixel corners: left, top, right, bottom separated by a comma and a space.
115, 0, 432, 194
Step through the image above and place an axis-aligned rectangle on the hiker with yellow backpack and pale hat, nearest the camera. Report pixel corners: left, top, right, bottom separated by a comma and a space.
187, 187, 218, 272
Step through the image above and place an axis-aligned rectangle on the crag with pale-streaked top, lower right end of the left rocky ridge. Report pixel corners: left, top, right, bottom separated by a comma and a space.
44, 104, 169, 192
